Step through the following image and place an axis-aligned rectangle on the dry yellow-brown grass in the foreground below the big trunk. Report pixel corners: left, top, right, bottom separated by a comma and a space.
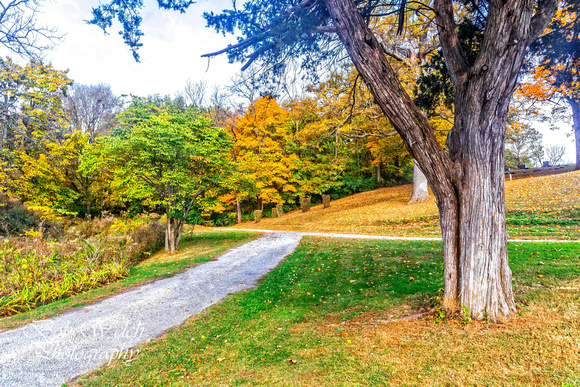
184, 283, 580, 386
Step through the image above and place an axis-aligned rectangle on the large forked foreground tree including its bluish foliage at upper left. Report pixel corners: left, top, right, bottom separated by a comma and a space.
89, 0, 557, 322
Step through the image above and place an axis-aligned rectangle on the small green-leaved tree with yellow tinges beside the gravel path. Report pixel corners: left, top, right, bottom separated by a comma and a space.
83, 97, 230, 252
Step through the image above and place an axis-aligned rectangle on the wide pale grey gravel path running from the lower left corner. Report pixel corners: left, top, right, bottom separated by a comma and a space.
0, 233, 302, 386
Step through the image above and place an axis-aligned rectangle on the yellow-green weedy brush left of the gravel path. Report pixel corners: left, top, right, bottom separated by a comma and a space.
0, 216, 165, 316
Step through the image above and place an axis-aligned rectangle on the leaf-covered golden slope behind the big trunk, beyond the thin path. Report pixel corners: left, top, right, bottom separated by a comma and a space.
231, 171, 580, 239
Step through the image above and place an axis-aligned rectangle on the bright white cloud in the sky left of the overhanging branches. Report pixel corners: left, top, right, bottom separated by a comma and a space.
0, 0, 240, 95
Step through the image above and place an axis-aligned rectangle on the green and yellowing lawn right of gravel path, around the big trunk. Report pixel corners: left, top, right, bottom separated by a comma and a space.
77, 238, 580, 386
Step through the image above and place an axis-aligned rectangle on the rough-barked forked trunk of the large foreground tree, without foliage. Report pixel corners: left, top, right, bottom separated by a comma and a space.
324, 0, 557, 322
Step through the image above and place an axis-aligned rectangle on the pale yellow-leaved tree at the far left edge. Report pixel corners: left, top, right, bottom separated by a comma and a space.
0, 58, 72, 198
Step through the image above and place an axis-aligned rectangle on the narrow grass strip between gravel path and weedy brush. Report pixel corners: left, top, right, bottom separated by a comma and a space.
0, 231, 257, 331
